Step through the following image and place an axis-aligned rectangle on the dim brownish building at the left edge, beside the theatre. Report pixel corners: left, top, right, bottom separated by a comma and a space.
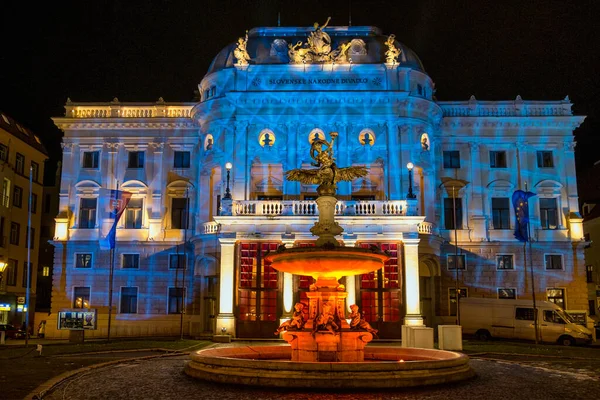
0, 112, 48, 326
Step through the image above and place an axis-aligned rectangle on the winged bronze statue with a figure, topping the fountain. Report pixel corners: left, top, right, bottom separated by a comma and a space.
285, 132, 369, 196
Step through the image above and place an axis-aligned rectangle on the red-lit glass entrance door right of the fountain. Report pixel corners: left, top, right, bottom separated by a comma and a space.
359, 243, 404, 339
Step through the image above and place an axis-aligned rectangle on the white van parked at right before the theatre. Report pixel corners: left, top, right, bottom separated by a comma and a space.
460, 297, 592, 346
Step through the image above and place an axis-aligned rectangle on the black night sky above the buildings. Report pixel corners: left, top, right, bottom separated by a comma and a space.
0, 0, 600, 188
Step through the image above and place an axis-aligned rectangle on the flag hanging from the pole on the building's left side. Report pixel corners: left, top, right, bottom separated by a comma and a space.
100, 189, 131, 250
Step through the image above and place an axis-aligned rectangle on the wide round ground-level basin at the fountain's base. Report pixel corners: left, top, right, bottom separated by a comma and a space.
185, 346, 475, 389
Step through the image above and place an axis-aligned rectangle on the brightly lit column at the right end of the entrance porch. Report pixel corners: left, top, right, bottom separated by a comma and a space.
403, 234, 423, 325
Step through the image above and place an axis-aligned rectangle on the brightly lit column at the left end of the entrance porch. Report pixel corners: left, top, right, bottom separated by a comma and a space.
216, 238, 235, 336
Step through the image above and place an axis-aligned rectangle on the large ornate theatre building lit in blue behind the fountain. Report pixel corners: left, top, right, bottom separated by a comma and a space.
47, 27, 588, 338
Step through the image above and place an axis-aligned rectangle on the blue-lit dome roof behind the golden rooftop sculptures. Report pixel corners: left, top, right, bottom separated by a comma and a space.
207, 26, 425, 74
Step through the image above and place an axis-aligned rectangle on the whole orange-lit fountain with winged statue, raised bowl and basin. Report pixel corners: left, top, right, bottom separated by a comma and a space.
185, 132, 474, 388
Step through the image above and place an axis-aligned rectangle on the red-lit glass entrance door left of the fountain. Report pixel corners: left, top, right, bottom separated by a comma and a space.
237, 242, 279, 338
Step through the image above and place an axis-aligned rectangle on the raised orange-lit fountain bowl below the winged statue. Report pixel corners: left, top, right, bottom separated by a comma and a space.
266, 246, 389, 279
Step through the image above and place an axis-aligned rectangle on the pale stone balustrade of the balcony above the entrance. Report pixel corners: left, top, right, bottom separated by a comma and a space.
232, 200, 406, 216
